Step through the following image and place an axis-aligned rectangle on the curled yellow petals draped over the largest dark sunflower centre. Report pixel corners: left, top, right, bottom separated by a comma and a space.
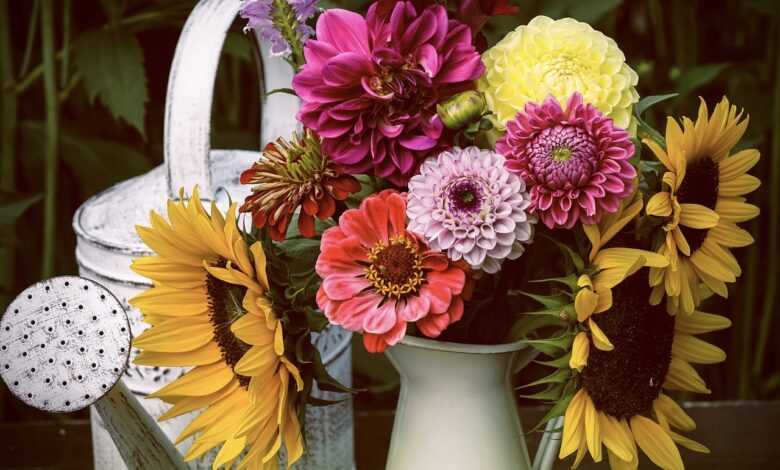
572, 193, 668, 352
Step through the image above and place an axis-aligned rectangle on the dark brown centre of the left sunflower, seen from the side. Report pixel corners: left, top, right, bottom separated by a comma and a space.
206, 262, 250, 388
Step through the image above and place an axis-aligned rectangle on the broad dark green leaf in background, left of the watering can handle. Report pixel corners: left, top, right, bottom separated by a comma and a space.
73, 30, 149, 138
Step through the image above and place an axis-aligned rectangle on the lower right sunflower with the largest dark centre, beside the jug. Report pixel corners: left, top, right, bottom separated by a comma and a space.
559, 273, 731, 470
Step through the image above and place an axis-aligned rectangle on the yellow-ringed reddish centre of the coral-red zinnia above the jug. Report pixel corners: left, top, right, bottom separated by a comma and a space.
365, 235, 425, 298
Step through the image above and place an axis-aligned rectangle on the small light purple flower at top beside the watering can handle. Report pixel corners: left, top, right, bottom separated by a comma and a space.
240, 0, 317, 56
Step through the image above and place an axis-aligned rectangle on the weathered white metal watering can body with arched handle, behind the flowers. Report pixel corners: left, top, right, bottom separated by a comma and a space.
73, 0, 354, 470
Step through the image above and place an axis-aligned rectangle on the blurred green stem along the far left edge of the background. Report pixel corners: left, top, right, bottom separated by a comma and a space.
0, 0, 17, 308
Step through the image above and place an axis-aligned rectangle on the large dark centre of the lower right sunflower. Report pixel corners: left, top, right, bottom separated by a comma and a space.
581, 271, 674, 418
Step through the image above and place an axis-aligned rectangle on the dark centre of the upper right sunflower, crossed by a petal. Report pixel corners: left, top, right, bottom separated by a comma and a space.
677, 157, 720, 252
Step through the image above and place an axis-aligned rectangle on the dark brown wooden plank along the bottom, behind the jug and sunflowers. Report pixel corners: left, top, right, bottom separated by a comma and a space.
0, 402, 780, 470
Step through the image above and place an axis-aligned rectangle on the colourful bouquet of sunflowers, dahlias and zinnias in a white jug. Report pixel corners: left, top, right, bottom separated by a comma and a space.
131, 0, 760, 469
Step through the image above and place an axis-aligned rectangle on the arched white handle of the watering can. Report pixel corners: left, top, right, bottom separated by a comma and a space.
164, 0, 298, 198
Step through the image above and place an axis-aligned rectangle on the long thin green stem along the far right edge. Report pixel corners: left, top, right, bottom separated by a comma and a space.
753, 21, 780, 379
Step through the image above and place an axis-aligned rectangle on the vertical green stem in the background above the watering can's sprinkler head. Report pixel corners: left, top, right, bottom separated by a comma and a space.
41, 0, 59, 279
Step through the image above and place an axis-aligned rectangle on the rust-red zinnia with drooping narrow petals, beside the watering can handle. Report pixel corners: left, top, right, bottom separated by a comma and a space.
240, 130, 360, 240
